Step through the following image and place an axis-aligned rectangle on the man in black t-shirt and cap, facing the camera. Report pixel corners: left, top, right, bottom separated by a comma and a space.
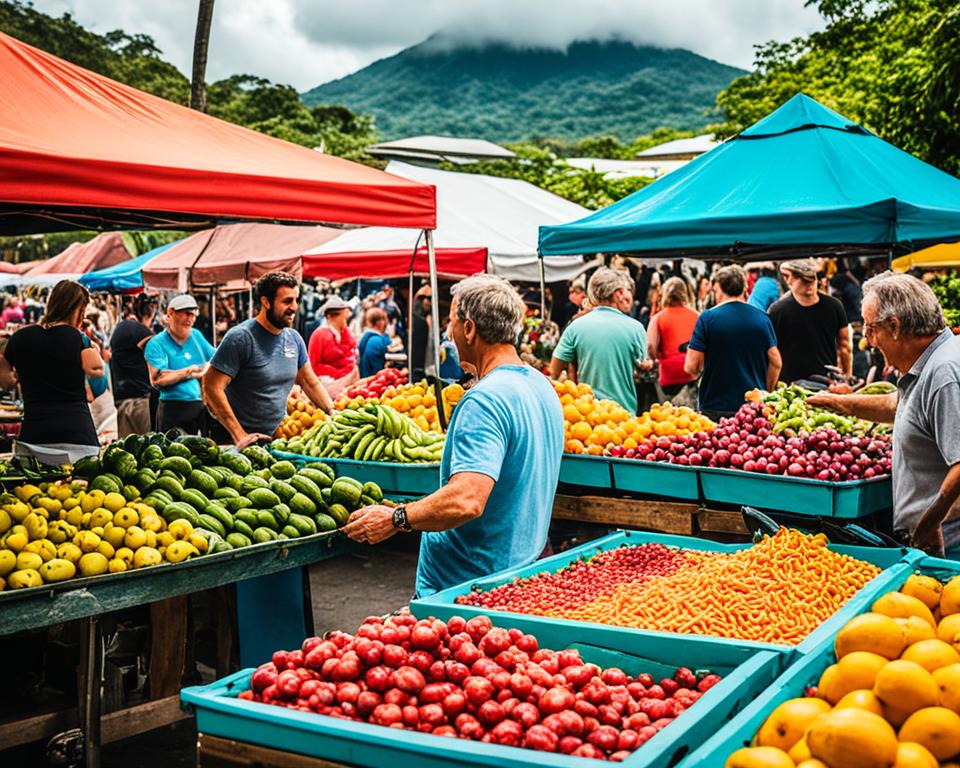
769, 259, 852, 383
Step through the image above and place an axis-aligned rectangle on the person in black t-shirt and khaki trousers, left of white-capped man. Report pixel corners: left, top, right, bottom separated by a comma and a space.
110, 294, 157, 437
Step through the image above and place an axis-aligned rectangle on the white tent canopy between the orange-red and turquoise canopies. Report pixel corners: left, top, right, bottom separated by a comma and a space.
304, 162, 587, 282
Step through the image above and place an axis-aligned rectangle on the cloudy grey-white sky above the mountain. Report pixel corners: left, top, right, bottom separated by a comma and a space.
34, 0, 821, 90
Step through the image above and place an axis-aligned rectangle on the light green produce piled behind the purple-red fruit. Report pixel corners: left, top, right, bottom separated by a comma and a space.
747, 382, 896, 437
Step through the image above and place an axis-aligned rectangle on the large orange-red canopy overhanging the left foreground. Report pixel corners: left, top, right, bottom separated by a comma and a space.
0, 33, 436, 234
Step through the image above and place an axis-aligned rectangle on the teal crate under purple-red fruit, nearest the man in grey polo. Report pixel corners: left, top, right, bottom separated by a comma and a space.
698, 467, 893, 519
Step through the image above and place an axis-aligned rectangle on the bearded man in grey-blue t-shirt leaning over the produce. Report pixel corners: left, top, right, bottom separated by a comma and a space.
203, 272, 333, 449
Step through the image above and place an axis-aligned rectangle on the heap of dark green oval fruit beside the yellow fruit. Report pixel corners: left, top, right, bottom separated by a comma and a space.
74, 433, 386, 552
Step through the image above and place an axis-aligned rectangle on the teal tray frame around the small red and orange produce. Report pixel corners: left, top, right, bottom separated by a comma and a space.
410, 531, 923, 668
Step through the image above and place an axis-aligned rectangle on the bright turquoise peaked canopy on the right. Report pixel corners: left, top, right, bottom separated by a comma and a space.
539, 94, 960, 259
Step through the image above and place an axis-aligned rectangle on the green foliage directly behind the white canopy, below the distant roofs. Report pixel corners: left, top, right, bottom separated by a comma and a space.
443, 144, 653, 209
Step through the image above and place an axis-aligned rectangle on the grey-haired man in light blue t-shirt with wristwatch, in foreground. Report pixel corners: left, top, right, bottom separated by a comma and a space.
343, 275, 563, 596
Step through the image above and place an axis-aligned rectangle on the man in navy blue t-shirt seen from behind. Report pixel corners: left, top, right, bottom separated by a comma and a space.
683, 266, 782, 420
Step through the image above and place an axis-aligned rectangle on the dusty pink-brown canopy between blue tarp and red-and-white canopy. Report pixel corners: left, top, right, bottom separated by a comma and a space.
143, 223, 346, 291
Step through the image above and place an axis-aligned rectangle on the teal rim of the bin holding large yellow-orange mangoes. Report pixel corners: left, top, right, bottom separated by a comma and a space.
680, 557, 960, 768
